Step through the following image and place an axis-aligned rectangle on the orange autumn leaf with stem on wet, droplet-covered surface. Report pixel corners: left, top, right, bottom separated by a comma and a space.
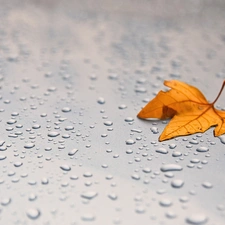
137, 80, 225, 141
